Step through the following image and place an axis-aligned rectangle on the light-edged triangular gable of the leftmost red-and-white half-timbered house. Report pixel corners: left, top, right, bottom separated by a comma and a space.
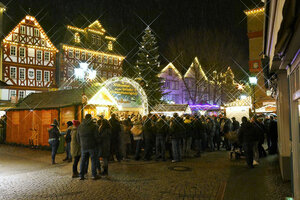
3, 15, 58, 51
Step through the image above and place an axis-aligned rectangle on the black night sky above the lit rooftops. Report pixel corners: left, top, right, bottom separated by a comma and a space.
2, 0, 260, 78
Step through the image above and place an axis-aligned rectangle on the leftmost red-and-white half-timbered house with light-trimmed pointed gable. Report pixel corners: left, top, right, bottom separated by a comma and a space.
1, 15, 58, 100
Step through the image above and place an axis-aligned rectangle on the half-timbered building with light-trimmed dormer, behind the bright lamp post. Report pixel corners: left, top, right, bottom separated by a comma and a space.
58, 20, 124, 89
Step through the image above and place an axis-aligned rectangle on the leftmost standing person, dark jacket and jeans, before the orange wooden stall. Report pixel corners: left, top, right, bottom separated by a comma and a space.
48, 119, 61, 164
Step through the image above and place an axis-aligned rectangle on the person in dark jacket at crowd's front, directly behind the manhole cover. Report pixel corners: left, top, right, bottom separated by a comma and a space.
170, 113, 185, 163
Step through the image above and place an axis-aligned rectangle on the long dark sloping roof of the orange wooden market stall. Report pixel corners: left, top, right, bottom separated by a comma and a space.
12, 87, 100, 110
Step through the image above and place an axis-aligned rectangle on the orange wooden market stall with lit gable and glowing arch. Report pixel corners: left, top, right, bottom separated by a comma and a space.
6, 77, 148, 146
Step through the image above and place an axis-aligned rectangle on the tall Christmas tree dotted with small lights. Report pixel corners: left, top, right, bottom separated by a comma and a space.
137, 26, 163, 110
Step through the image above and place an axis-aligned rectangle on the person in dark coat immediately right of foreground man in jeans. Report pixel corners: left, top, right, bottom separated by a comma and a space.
99, 119, 111, 176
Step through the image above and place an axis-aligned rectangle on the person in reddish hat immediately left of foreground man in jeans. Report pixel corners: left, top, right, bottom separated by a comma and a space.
71, 120, 81, 178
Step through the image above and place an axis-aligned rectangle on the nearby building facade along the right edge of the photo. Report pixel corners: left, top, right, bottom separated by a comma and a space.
262, 0, 300, 200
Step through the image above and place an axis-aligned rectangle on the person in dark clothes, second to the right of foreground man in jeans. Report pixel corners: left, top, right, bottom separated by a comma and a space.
109, 113, 122, 161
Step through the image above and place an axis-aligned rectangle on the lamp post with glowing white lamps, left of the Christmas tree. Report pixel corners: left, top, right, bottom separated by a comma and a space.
74, 63, 97, 119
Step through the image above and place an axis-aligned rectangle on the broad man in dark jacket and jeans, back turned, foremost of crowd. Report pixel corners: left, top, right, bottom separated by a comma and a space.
77, 114, 99, 180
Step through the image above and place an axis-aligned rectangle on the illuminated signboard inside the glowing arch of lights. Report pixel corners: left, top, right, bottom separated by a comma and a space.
106, 81, 142, 108
